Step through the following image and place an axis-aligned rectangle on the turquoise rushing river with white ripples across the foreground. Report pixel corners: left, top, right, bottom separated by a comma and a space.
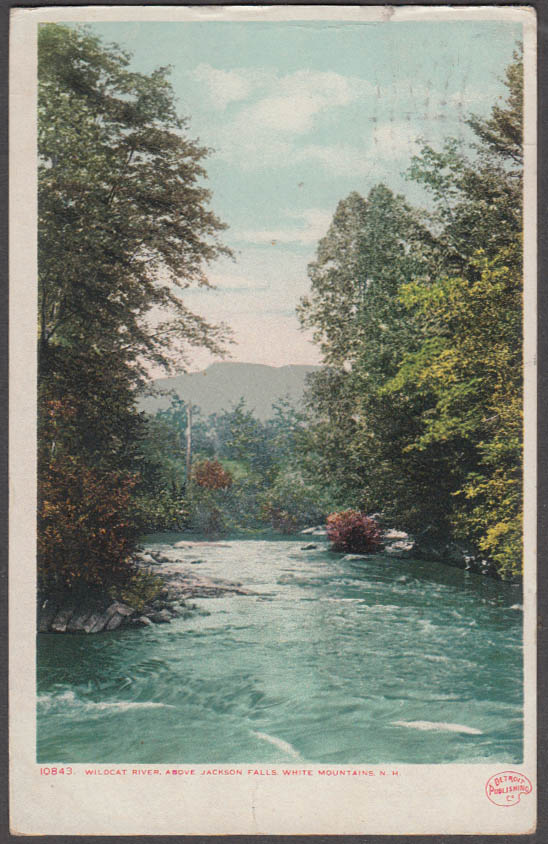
38, 535, 523, 764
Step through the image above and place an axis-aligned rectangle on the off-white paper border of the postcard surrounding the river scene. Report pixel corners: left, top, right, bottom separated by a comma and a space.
10, 6, 537, 835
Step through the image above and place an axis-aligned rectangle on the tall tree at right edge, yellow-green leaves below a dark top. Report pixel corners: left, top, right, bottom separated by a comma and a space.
388, 51, 523, 577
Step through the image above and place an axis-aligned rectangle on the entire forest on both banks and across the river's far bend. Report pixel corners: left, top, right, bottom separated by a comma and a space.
38, 24, 523, 612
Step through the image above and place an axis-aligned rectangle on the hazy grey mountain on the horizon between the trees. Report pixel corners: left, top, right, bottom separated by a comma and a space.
139, 361, 320, 421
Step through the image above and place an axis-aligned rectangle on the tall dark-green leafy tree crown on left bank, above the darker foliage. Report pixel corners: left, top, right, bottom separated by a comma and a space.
38, 24, 228, 369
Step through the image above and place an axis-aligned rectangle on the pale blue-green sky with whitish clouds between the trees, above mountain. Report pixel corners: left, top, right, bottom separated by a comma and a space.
90, 20, 521, 371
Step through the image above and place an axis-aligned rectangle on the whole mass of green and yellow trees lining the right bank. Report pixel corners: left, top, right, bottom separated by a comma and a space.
299, 54, 523, 578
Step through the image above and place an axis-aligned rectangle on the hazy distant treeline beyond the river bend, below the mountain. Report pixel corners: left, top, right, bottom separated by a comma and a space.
144, 397, 330, 536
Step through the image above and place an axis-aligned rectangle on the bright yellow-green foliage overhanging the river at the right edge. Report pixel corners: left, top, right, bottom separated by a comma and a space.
388, 254, 523, 577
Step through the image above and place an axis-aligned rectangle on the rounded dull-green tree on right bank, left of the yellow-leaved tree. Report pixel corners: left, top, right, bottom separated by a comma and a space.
300, 185, 447, 531
